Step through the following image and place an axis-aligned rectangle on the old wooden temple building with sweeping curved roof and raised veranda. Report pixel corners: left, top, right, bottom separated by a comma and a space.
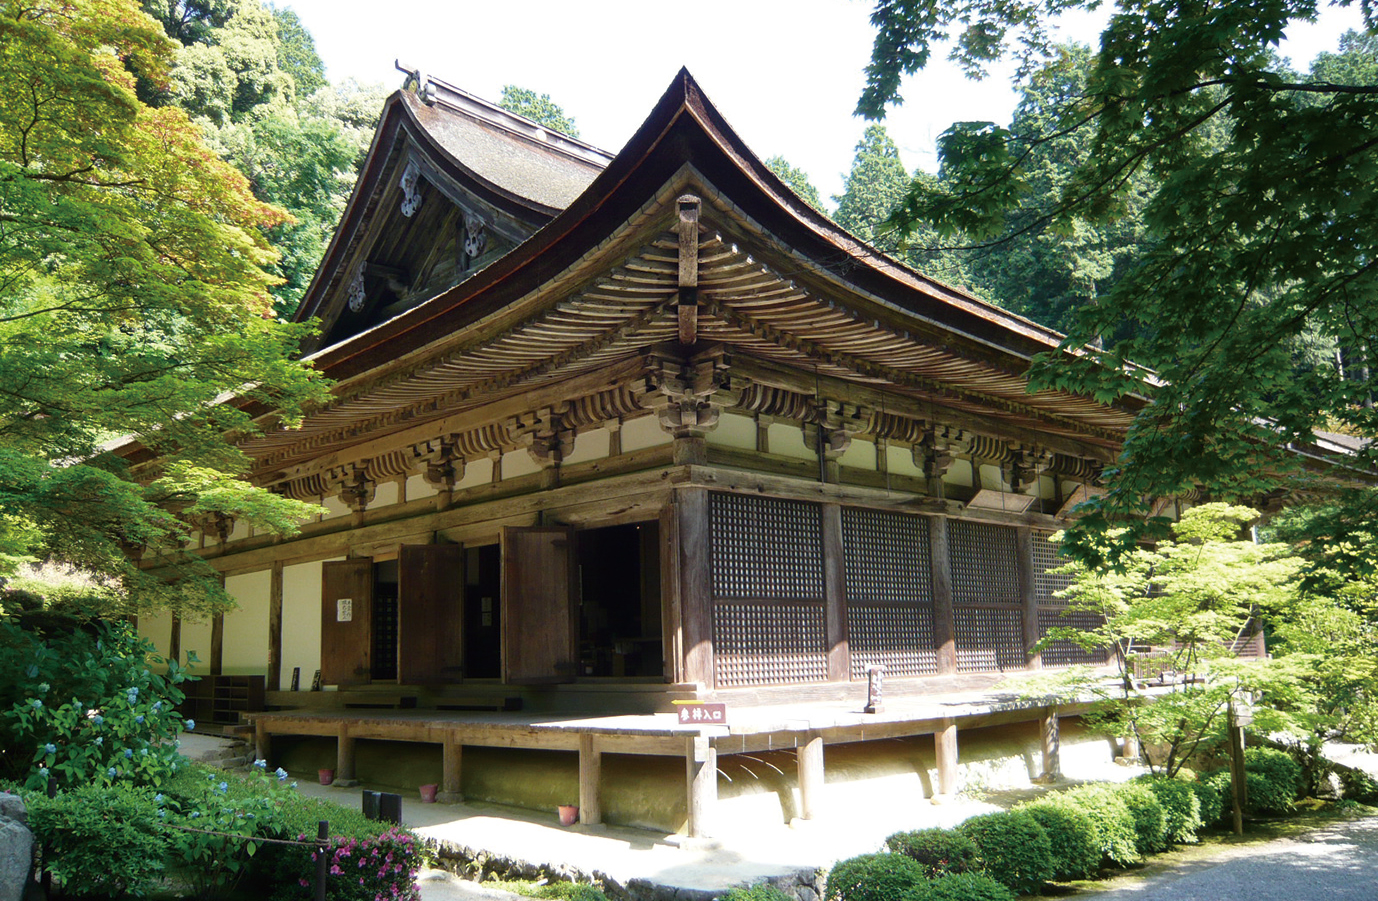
126, 72, 1196, 832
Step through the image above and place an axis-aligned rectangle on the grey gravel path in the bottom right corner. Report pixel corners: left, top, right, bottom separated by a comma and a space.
1078, 817, 1378, 901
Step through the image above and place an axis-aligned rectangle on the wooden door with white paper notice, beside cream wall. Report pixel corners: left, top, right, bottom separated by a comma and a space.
321, 559, 373, 685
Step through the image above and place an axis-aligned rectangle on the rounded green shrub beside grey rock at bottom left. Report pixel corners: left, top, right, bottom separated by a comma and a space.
25, 784, 168, 898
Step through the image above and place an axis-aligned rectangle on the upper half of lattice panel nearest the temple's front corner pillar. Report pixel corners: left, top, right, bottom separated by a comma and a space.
710, 493, 823, 601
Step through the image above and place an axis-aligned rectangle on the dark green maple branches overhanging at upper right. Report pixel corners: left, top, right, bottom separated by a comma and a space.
858, 0, 1378, 554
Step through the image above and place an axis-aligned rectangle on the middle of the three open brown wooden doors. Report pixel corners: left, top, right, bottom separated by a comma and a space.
397, 544, 464, 683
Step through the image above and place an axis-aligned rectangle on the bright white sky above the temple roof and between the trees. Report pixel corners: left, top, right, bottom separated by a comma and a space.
278, 0, 1361, 205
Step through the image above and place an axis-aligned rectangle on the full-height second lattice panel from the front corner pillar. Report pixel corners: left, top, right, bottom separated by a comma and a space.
842, 507, 938, 679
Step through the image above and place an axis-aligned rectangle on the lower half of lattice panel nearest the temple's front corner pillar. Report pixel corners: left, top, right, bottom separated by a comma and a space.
712, 603, 828, 687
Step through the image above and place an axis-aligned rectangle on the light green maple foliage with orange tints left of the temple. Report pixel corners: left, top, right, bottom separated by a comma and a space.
0, 0, 321, 614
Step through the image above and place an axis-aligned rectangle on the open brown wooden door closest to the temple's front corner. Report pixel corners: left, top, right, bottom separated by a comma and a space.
500, 526, 579, 683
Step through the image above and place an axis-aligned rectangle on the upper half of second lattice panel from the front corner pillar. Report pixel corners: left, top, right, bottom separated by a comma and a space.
842, 507, 933, 605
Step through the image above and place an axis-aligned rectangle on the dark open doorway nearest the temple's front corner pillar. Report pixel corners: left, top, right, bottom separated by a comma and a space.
577, 522, 664, 676
